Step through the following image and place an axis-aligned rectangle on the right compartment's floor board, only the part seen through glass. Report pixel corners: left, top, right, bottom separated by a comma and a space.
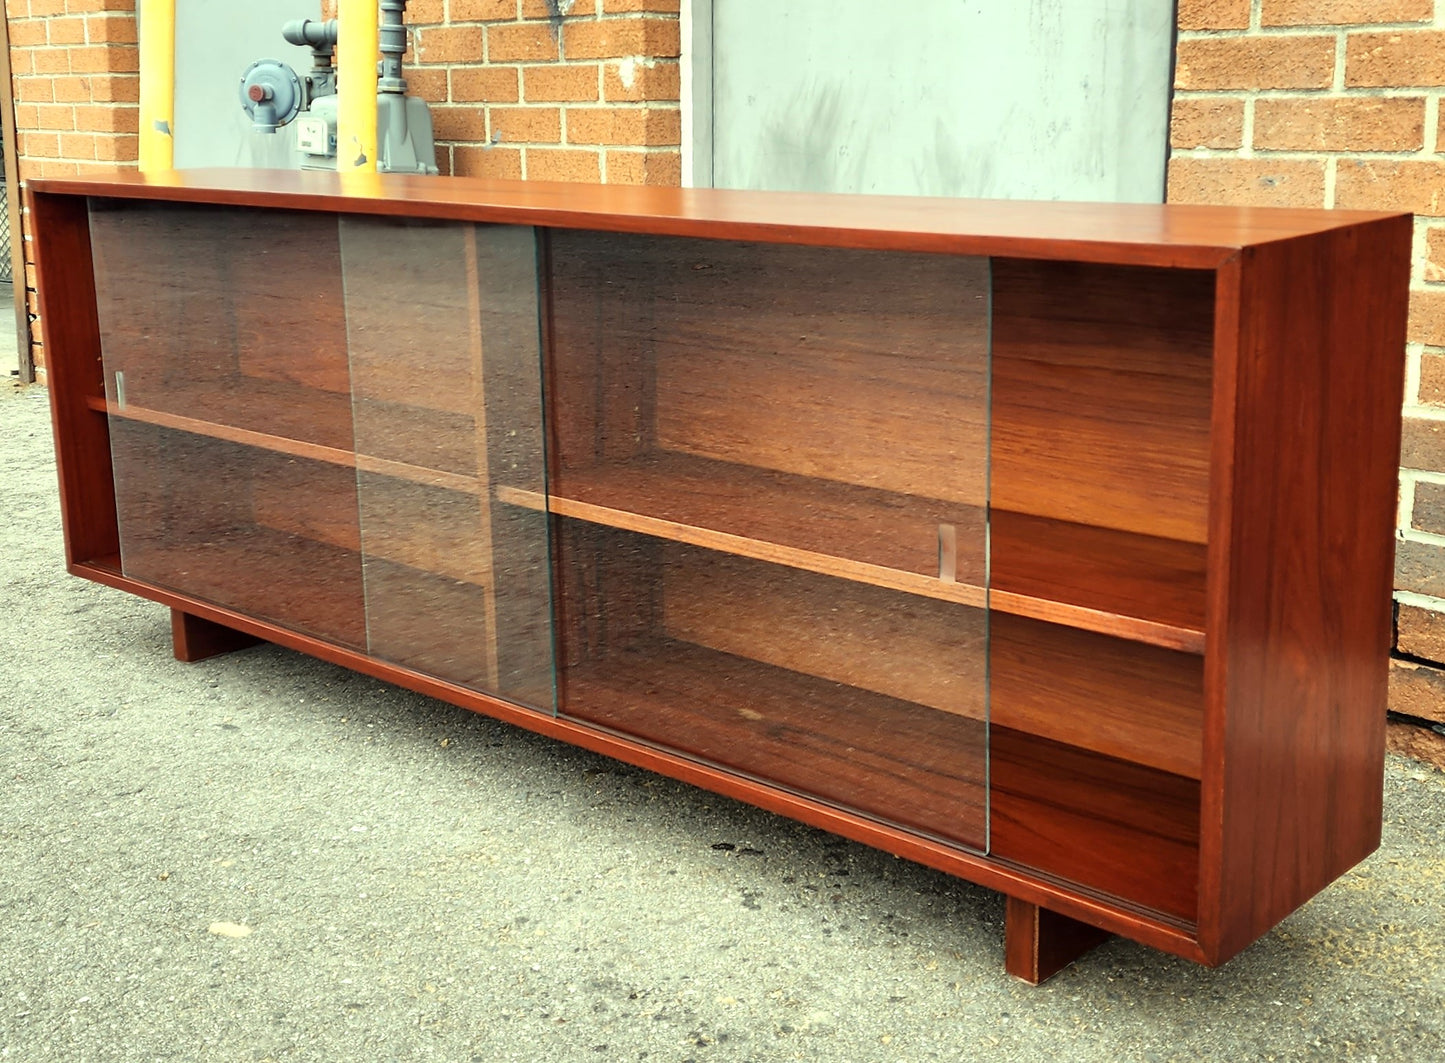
561, 638, 987, 848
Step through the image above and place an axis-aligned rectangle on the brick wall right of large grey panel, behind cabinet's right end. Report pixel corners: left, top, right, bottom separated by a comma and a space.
1169, 0, 1445, 724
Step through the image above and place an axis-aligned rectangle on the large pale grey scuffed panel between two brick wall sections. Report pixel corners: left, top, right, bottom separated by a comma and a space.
711, 0, 1175, 202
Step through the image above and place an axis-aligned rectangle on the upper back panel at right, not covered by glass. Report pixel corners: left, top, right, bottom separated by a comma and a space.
991, 259, 1214, 543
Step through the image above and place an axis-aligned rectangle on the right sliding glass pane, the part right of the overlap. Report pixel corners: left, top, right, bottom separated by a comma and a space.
548, 231, 990, 848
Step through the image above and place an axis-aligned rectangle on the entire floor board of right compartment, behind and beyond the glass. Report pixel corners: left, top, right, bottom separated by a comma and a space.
561, 638, 1199, 921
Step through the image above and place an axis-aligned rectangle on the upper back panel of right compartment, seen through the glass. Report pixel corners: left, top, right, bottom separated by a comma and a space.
551, 231, 988, 504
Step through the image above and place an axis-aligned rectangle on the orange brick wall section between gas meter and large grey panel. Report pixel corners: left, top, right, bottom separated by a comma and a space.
323, 0, 682, 185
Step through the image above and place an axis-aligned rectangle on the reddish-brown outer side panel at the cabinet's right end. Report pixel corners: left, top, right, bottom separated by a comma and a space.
1204, 217, 1412, 960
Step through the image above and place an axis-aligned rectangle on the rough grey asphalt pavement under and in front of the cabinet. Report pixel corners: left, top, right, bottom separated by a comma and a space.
0, 384, 1445, 1063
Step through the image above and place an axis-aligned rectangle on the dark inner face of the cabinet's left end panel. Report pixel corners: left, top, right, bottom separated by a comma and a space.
30, 194, 120, 565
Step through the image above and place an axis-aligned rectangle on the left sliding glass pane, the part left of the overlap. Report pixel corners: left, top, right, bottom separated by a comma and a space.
91, 201, 366, 648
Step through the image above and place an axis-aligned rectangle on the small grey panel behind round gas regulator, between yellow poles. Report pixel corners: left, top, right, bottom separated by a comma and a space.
175, 0, 321, 169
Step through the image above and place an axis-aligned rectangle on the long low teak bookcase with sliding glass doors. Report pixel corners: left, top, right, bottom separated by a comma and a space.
29, 170, 1412, 981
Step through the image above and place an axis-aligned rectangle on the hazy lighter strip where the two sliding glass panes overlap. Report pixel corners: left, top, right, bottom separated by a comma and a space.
341, 217, 555, 711
